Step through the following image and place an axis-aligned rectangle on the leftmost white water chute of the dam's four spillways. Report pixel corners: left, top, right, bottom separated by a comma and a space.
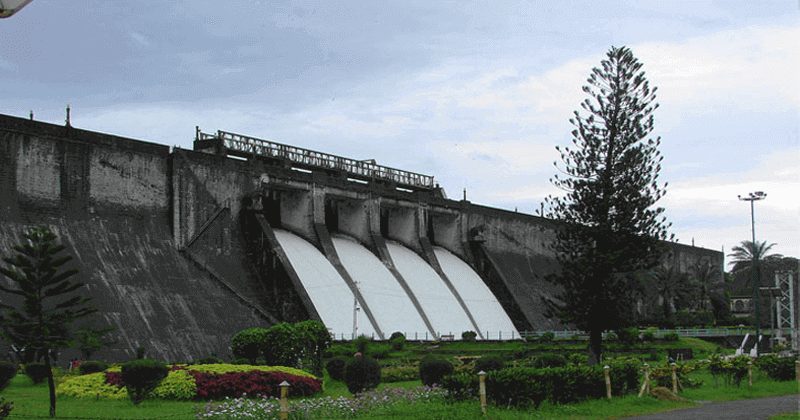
275, 229, 375, 338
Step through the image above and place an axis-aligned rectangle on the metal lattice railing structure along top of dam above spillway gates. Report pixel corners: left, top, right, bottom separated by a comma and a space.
196, 129, 435, 189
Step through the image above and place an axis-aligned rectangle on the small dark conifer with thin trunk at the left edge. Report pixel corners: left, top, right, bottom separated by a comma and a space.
0, 227, 95, 417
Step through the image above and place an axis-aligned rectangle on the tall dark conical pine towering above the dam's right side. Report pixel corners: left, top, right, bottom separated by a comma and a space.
545, 47, 669, 363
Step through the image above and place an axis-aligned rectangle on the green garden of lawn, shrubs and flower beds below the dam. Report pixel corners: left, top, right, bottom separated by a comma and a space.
0, 321, 798, 419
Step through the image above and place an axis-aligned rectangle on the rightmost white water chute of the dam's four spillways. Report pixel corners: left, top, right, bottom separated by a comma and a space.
433, 246, 519, 340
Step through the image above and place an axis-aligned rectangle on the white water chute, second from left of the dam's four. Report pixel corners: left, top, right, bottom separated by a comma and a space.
333, 235, 432, 339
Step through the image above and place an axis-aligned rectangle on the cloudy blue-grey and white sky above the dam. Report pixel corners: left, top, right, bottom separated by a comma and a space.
0, 0, 800, 266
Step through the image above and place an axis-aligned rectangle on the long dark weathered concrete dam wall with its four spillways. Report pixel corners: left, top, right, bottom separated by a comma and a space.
0, 115, 722, 360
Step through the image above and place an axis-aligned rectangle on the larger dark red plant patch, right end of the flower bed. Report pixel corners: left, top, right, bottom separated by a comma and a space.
189, 370, 322, 399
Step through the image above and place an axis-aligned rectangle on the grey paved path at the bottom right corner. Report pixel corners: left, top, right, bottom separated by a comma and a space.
630, 394, 800, 420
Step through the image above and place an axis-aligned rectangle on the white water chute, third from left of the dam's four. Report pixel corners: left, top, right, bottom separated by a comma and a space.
386, 241, 475, 337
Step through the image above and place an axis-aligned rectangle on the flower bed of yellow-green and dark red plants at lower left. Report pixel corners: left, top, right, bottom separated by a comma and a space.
57, 364, 322, 400
